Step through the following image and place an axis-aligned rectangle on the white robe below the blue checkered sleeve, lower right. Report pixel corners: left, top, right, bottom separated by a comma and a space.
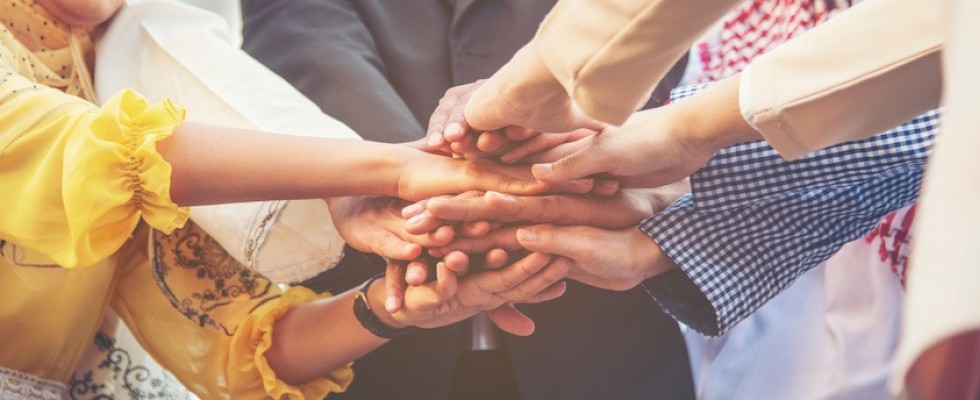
684, 239, 905, 400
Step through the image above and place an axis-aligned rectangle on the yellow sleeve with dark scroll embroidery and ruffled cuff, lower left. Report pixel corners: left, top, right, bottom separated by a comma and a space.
110, 222, 354, 400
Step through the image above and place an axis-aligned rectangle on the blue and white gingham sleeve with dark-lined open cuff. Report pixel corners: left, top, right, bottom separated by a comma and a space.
639, 86, 939, 336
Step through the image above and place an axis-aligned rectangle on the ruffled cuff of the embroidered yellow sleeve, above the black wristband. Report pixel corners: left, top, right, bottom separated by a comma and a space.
228, 287, 354, 399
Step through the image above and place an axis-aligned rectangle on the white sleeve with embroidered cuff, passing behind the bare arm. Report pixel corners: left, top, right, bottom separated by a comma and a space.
95, 0, 358, 282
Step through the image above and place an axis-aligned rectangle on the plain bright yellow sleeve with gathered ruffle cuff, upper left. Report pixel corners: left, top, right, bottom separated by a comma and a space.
0, 64, 188, 268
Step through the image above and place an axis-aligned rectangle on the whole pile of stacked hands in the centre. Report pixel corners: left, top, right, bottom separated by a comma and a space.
328, 77, 712, 335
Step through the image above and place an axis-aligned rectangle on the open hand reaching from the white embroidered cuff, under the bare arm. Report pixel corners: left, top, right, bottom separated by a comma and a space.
326, 196, 454, 260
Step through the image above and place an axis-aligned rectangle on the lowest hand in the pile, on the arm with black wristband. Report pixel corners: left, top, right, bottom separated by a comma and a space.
386, 253, 569, 336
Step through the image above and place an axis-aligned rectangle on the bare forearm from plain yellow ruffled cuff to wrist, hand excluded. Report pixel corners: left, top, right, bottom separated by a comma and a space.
157, 123, 403, 206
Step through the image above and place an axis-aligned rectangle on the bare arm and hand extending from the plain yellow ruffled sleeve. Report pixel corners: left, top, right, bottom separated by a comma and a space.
158, 123, 576, 206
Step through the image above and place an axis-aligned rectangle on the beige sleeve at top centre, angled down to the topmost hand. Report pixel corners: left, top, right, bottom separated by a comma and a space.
531, 0, 742, 125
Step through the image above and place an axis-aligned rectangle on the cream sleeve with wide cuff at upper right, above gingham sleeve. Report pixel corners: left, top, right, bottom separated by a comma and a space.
739, 0, 943, 159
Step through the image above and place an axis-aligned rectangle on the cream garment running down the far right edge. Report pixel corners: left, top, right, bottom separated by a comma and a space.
892, 0, 980, 392
